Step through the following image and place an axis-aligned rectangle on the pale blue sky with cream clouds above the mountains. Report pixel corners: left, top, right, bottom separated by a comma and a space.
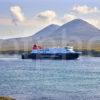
0, 0, 100, 38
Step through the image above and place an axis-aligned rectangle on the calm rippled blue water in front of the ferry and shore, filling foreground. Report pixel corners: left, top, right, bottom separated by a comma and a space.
0, 56, 100, 100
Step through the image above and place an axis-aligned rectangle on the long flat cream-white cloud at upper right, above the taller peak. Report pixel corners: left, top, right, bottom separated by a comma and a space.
72, 5, 99, 14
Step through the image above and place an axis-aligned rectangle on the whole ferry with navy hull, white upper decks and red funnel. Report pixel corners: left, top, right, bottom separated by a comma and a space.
22, 45, 80, 60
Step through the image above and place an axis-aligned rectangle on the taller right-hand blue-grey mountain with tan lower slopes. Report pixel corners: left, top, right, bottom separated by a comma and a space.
41, 19, 100, 49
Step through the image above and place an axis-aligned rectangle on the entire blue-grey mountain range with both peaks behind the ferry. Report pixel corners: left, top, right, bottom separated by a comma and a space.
0, 19, 100, 51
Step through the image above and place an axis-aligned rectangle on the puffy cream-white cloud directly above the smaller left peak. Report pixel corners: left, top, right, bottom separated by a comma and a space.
30, 10, 62, 26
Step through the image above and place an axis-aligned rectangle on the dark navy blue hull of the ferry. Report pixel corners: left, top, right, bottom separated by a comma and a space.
22, 52, 80, 60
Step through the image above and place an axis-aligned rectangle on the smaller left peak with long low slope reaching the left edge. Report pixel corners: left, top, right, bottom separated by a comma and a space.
0, 24, 60, 51
